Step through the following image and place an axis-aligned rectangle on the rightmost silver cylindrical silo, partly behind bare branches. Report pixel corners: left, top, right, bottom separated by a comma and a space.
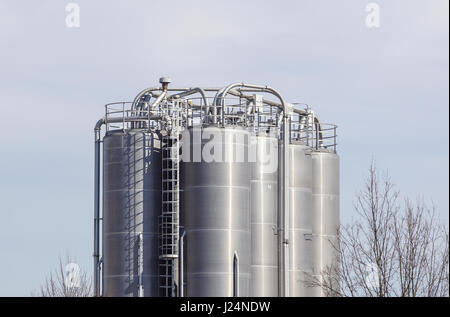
312, 149, 339, 296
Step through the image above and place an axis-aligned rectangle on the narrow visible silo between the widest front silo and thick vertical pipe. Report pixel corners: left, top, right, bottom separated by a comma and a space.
250, 135, 278, 297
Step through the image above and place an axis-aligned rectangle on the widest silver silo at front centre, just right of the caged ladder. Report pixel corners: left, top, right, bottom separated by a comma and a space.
180, 127, 251, 297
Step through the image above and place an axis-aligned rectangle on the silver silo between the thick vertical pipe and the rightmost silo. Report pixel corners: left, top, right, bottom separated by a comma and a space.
288, 144, 312, 297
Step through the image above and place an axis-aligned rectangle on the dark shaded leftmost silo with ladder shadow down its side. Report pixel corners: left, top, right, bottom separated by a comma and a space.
102, 130, 161, 296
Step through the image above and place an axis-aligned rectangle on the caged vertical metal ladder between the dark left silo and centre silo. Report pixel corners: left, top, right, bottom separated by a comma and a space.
159, 102, 179, 297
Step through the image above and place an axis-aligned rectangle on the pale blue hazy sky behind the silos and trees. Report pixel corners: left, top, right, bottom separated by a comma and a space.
0, 0, 449, 296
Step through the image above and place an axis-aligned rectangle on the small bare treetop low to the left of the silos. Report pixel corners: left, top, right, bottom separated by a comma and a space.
33, 256, 92, 297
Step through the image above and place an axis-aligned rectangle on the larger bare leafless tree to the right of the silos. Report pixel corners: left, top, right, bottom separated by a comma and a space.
307, 163, 449, 297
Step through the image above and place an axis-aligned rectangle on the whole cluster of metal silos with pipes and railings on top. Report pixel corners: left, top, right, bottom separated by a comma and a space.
94, 78, 339, 297
